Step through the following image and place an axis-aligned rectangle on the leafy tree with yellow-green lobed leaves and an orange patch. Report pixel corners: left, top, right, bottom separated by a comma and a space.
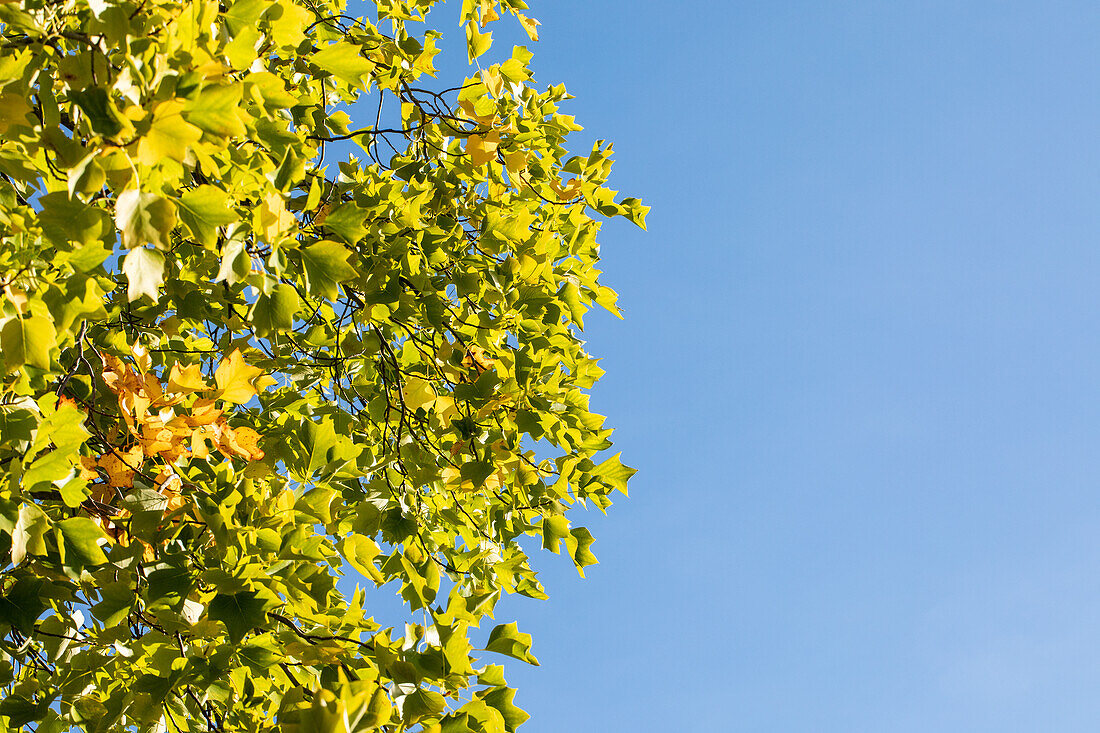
0, 0, 647, 733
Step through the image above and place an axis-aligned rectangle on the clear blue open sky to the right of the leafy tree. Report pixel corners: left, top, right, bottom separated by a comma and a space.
451, 0, 1100, 733
